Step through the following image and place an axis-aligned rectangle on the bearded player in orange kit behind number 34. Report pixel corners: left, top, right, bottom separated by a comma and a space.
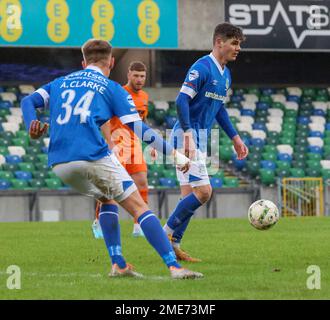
92, 61, 157, 238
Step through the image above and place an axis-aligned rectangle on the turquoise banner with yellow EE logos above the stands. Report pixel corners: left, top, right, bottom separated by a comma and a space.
0, 0, 178, 48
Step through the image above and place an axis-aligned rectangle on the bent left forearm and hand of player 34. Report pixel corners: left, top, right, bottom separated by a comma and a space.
21, 92, 48, 139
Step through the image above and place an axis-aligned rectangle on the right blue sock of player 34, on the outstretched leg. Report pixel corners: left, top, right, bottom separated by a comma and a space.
138, 210, 181, 268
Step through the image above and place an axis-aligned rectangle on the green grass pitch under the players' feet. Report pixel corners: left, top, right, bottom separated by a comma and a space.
0, 217, 330, 300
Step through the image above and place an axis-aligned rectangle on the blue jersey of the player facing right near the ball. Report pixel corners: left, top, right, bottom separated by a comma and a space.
171, 53, 231, 147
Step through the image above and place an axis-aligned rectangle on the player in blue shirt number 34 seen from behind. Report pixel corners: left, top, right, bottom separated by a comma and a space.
21, 39, 203, 279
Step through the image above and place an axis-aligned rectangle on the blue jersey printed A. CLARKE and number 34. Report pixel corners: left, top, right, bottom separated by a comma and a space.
36, 66, 140, 166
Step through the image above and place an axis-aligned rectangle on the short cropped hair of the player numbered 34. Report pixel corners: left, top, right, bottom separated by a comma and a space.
81, 39, 112, 64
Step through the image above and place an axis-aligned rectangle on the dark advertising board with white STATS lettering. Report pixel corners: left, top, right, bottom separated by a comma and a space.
225, 0, 330, 51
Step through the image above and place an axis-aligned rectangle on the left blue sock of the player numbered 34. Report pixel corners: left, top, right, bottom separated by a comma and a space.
99, 204, 126, 269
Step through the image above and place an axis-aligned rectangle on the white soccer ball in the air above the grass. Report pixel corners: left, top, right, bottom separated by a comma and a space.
248, 199, 280, 230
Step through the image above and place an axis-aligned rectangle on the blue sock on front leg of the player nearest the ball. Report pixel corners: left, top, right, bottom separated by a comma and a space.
164, 193, 202, 234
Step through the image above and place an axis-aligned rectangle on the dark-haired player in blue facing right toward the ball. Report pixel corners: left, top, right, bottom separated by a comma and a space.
164, 23, 248, 262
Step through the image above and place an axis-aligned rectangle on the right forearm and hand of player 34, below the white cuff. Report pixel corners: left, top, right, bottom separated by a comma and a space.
126, 120, 190, 172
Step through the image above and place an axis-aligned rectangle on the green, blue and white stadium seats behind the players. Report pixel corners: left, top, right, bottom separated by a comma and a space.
0, 84, 330, 190
